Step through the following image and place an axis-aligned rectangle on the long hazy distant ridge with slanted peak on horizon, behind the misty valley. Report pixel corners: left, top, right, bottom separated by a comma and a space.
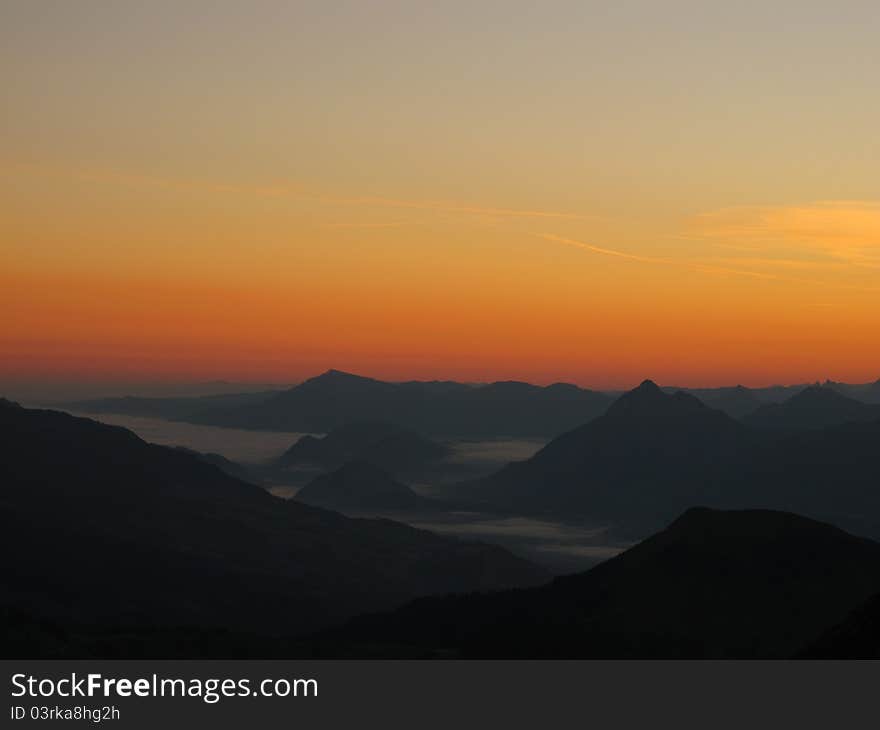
68, 370, 611, 437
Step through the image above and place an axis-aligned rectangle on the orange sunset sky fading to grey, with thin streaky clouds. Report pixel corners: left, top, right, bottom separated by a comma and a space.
0, 0, 880, 388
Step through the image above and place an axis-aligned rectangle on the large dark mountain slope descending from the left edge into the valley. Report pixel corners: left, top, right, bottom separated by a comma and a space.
0, 404, 545, 648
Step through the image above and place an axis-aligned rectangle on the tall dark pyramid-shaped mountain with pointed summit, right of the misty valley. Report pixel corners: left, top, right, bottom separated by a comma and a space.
468, 380, 754, 524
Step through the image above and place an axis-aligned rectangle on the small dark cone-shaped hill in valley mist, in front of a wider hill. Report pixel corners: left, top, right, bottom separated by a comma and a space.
296, 461, 436, 514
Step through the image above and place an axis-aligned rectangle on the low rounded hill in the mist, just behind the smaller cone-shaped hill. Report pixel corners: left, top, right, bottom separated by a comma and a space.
278, 422, 449, 472
